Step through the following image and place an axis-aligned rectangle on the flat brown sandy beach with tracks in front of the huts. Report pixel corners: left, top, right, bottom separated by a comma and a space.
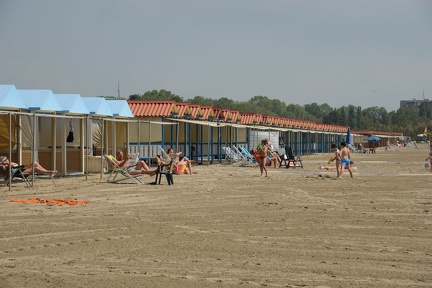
0, 145, 432, 287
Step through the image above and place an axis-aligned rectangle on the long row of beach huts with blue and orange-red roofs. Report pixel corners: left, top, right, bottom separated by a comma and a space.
0, 85, 403, 175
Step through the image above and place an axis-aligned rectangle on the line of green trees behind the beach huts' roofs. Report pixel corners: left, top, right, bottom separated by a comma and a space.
129, 89, 432, 139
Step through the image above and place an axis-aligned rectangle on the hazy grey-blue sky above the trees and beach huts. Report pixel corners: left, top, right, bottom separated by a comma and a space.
0, 0, 432, 112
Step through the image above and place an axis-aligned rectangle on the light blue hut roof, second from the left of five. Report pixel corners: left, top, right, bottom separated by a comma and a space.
18, 90, 64, 112
